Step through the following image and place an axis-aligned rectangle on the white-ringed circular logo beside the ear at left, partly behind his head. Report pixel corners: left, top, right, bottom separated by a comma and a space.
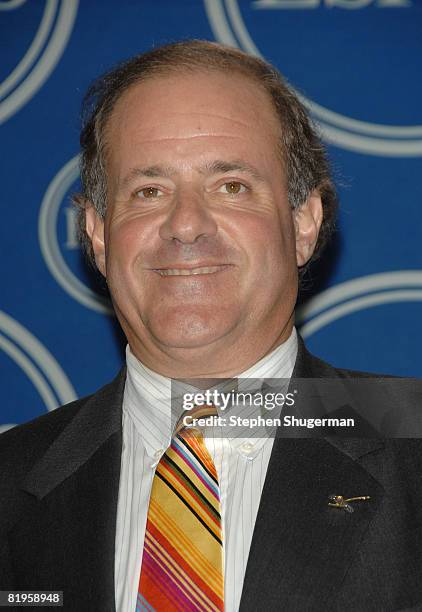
38, 156, 113, 314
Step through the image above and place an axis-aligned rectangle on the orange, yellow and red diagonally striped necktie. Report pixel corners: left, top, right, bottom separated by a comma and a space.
136, 407, 224, 612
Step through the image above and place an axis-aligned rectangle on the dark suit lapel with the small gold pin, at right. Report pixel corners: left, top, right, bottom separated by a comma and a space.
240, 340, 384, 612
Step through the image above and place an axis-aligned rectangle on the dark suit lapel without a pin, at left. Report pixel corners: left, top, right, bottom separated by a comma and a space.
9, 370, 125, 611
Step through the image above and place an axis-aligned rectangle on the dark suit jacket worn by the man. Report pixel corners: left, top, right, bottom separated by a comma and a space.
0, 343, 422, 612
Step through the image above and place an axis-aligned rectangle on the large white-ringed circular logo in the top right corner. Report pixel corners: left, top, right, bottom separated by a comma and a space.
204, 0, 422, 157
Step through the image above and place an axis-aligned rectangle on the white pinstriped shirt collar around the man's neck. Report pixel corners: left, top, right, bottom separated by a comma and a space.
123, 328, 298, 459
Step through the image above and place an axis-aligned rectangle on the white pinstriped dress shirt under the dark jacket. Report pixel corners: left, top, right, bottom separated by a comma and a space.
115, 329, 297, 612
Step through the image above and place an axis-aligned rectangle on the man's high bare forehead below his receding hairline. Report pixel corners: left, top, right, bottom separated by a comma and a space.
105, 71, 280, 169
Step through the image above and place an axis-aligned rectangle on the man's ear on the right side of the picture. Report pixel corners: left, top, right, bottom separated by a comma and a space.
293, 189, 323, 268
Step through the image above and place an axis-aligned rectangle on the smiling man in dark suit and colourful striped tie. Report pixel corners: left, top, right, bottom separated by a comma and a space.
0, 41, 422, 612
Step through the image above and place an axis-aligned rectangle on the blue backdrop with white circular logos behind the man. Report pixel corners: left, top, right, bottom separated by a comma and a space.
0, 0, 422, 429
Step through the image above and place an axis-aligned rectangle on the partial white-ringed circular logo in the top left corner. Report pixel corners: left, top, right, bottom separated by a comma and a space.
0, 0, 79, 124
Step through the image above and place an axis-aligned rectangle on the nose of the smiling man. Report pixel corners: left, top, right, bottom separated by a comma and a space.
160, 190, 217, 244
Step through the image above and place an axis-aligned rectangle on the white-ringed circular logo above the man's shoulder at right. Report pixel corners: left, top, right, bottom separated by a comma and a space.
296, 270, 422, 377
